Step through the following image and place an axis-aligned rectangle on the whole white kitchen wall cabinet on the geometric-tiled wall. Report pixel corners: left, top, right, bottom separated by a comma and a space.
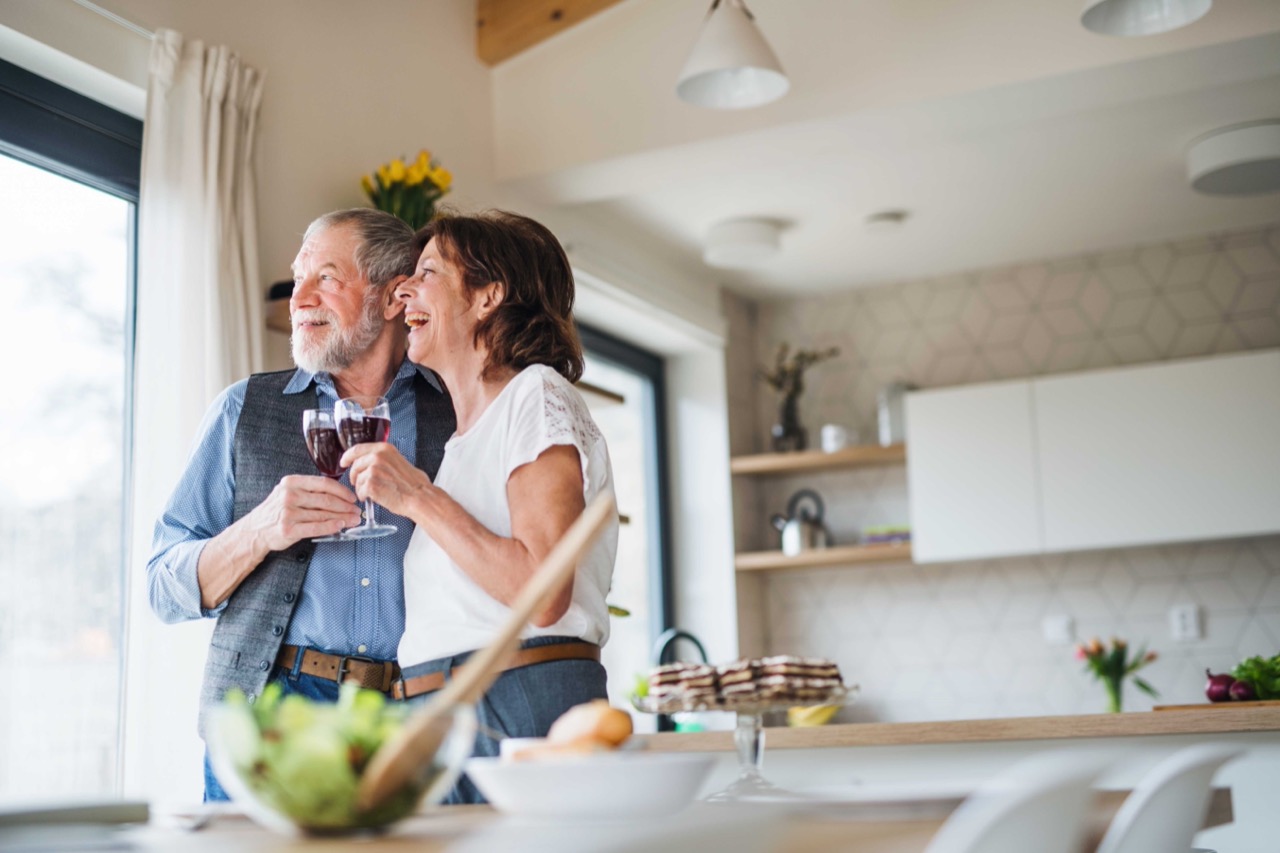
908, 351, 1280, 562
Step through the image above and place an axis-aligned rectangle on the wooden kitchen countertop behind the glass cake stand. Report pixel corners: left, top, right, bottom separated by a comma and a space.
648, 703, 1280, 752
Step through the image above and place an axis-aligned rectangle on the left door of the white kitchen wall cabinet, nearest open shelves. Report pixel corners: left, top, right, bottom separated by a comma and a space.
906, 382, 1041, 562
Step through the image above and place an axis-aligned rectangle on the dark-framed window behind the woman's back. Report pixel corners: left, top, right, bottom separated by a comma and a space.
580, 322, 671, 730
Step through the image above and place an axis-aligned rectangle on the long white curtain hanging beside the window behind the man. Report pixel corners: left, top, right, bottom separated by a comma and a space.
122, 29, 262, 800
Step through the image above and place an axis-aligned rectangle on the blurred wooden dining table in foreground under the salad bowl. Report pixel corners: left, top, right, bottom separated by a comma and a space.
118, 788, 1233, 853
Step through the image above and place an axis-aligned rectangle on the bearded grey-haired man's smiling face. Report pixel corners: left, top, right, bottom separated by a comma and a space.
289, 225, 385, 373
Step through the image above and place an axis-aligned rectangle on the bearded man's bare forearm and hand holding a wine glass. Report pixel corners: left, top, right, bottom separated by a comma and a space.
196, 474, 360, 610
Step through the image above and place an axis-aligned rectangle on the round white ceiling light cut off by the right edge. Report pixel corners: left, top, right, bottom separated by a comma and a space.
1187, 119, 1280, 196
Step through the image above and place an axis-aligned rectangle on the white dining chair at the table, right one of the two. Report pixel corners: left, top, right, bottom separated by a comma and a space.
1098, 744, 1244, 853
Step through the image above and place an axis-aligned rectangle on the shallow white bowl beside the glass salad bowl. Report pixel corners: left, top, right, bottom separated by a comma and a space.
466, 751, 716, 820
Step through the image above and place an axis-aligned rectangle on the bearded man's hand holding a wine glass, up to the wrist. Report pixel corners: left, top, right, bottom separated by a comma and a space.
243, 474, 360, 556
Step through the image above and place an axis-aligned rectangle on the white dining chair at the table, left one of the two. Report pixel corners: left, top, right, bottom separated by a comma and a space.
927, 751, 1107, 853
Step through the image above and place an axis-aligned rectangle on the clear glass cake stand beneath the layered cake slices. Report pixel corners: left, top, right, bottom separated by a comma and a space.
631, 684, 858, 803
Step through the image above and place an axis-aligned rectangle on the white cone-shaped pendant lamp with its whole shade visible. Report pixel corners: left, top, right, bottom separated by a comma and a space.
676, 0, 791, 110
